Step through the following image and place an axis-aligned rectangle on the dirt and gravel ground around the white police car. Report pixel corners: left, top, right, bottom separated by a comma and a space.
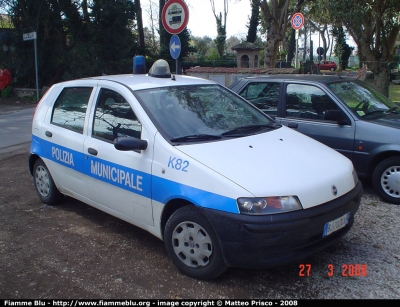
0, 107, 400, 299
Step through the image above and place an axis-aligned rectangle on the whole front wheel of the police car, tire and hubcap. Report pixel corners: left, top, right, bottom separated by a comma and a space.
164, 206, 227, 280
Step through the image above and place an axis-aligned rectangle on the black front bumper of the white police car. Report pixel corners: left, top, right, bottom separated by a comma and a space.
204, 182, 362, 268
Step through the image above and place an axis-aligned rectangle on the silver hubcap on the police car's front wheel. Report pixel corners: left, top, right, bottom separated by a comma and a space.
172, 222, 212, 268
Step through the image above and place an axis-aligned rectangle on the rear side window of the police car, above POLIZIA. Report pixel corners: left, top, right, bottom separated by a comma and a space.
51, 87, 93, 133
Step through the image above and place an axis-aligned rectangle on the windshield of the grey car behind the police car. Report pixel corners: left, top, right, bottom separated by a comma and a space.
328, 80, 400, 119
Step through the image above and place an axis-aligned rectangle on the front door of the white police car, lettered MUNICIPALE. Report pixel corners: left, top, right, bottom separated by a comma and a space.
83, 81, 154, 229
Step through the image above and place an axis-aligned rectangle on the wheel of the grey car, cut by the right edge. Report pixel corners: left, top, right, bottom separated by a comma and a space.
372, 157, 400, 205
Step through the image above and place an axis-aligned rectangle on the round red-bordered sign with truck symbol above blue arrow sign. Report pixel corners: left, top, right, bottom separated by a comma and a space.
161, 0, 189, 34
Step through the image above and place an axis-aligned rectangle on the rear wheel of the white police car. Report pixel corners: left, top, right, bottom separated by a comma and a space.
33, 159, 62, 205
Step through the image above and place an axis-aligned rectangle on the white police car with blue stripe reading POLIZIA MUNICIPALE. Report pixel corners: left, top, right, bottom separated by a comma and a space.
29, 58, 362, 279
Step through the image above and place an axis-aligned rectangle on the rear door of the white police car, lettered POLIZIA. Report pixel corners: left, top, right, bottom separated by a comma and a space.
39, 80, 95, 198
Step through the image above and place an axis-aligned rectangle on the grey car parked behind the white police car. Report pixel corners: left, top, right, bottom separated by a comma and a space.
230, 75, 400, 204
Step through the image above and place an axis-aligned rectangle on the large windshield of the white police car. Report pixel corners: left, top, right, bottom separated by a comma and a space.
135, 85, 280, 143
